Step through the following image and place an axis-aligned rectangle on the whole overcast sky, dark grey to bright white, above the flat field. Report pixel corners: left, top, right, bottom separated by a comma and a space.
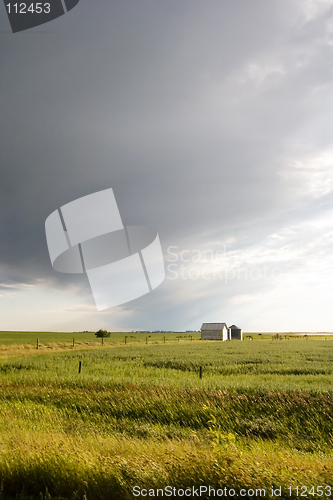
0, 0, 333, 332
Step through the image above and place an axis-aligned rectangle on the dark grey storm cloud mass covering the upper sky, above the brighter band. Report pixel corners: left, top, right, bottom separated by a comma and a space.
0, 0, 331, 324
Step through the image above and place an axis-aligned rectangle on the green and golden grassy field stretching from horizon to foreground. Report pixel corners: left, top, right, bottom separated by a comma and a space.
0, 332, 333, 500
